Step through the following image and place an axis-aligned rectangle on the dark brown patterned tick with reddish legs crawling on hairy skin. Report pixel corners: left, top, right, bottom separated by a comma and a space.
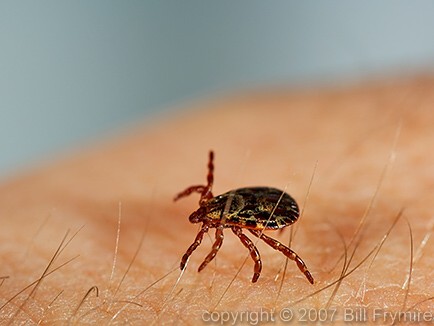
174, 151, 314, 284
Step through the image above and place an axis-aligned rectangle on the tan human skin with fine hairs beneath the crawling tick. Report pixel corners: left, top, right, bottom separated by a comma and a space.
0, 77, 434, 324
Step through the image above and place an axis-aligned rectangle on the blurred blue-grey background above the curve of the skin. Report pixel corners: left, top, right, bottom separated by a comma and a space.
0, 0, 434, 178
